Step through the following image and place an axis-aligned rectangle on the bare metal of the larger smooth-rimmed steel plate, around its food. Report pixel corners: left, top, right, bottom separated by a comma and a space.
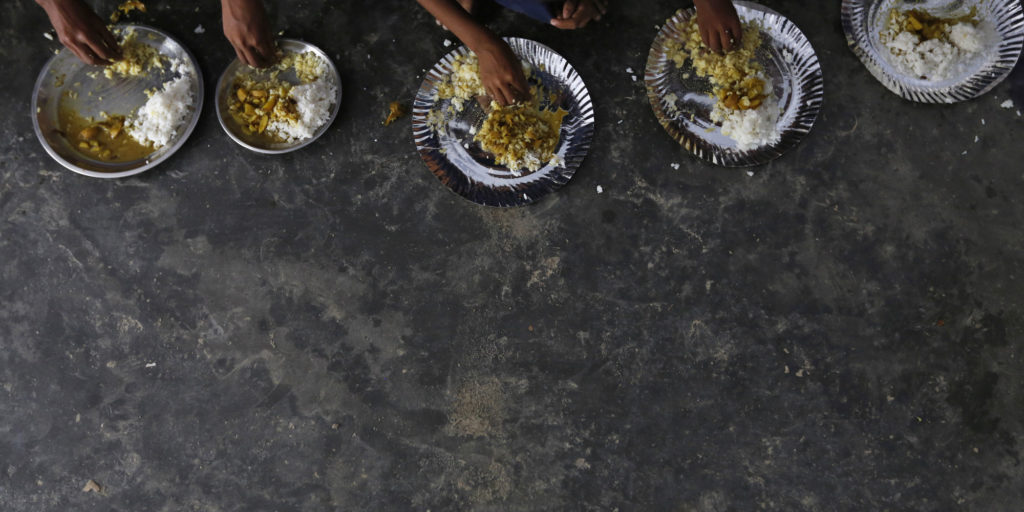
32, 25, 204, 178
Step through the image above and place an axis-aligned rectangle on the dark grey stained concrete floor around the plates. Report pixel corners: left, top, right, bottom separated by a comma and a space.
0, 0, 1024, 511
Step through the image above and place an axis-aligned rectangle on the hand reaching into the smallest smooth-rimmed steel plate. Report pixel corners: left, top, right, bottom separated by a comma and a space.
220, 0, 278, 68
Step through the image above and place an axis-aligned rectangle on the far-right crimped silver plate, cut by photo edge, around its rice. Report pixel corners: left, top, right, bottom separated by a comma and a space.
842, 0, 1024, 103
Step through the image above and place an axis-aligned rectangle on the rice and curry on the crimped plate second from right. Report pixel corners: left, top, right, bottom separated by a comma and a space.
666, 16, 781, 151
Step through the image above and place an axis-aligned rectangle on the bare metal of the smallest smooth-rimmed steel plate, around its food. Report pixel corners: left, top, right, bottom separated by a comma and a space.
216, 39, 341, 155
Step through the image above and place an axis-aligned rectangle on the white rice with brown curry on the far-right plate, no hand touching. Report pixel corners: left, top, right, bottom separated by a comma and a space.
880, 7, 984, 82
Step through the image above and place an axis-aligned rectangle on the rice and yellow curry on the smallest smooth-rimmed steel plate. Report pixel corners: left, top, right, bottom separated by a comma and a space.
228, 51, 338, 142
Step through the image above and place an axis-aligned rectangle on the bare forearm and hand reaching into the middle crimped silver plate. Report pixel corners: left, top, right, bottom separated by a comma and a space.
418, 0, 529, 104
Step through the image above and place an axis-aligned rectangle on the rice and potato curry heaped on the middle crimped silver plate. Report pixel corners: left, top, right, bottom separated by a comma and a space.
431, 53, 568, 176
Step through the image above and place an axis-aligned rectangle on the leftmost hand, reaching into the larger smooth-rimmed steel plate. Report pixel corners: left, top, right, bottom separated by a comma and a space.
38, 0, 121, 66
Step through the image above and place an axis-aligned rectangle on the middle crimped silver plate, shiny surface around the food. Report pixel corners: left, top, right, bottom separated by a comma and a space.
413, 38, 594, 207
